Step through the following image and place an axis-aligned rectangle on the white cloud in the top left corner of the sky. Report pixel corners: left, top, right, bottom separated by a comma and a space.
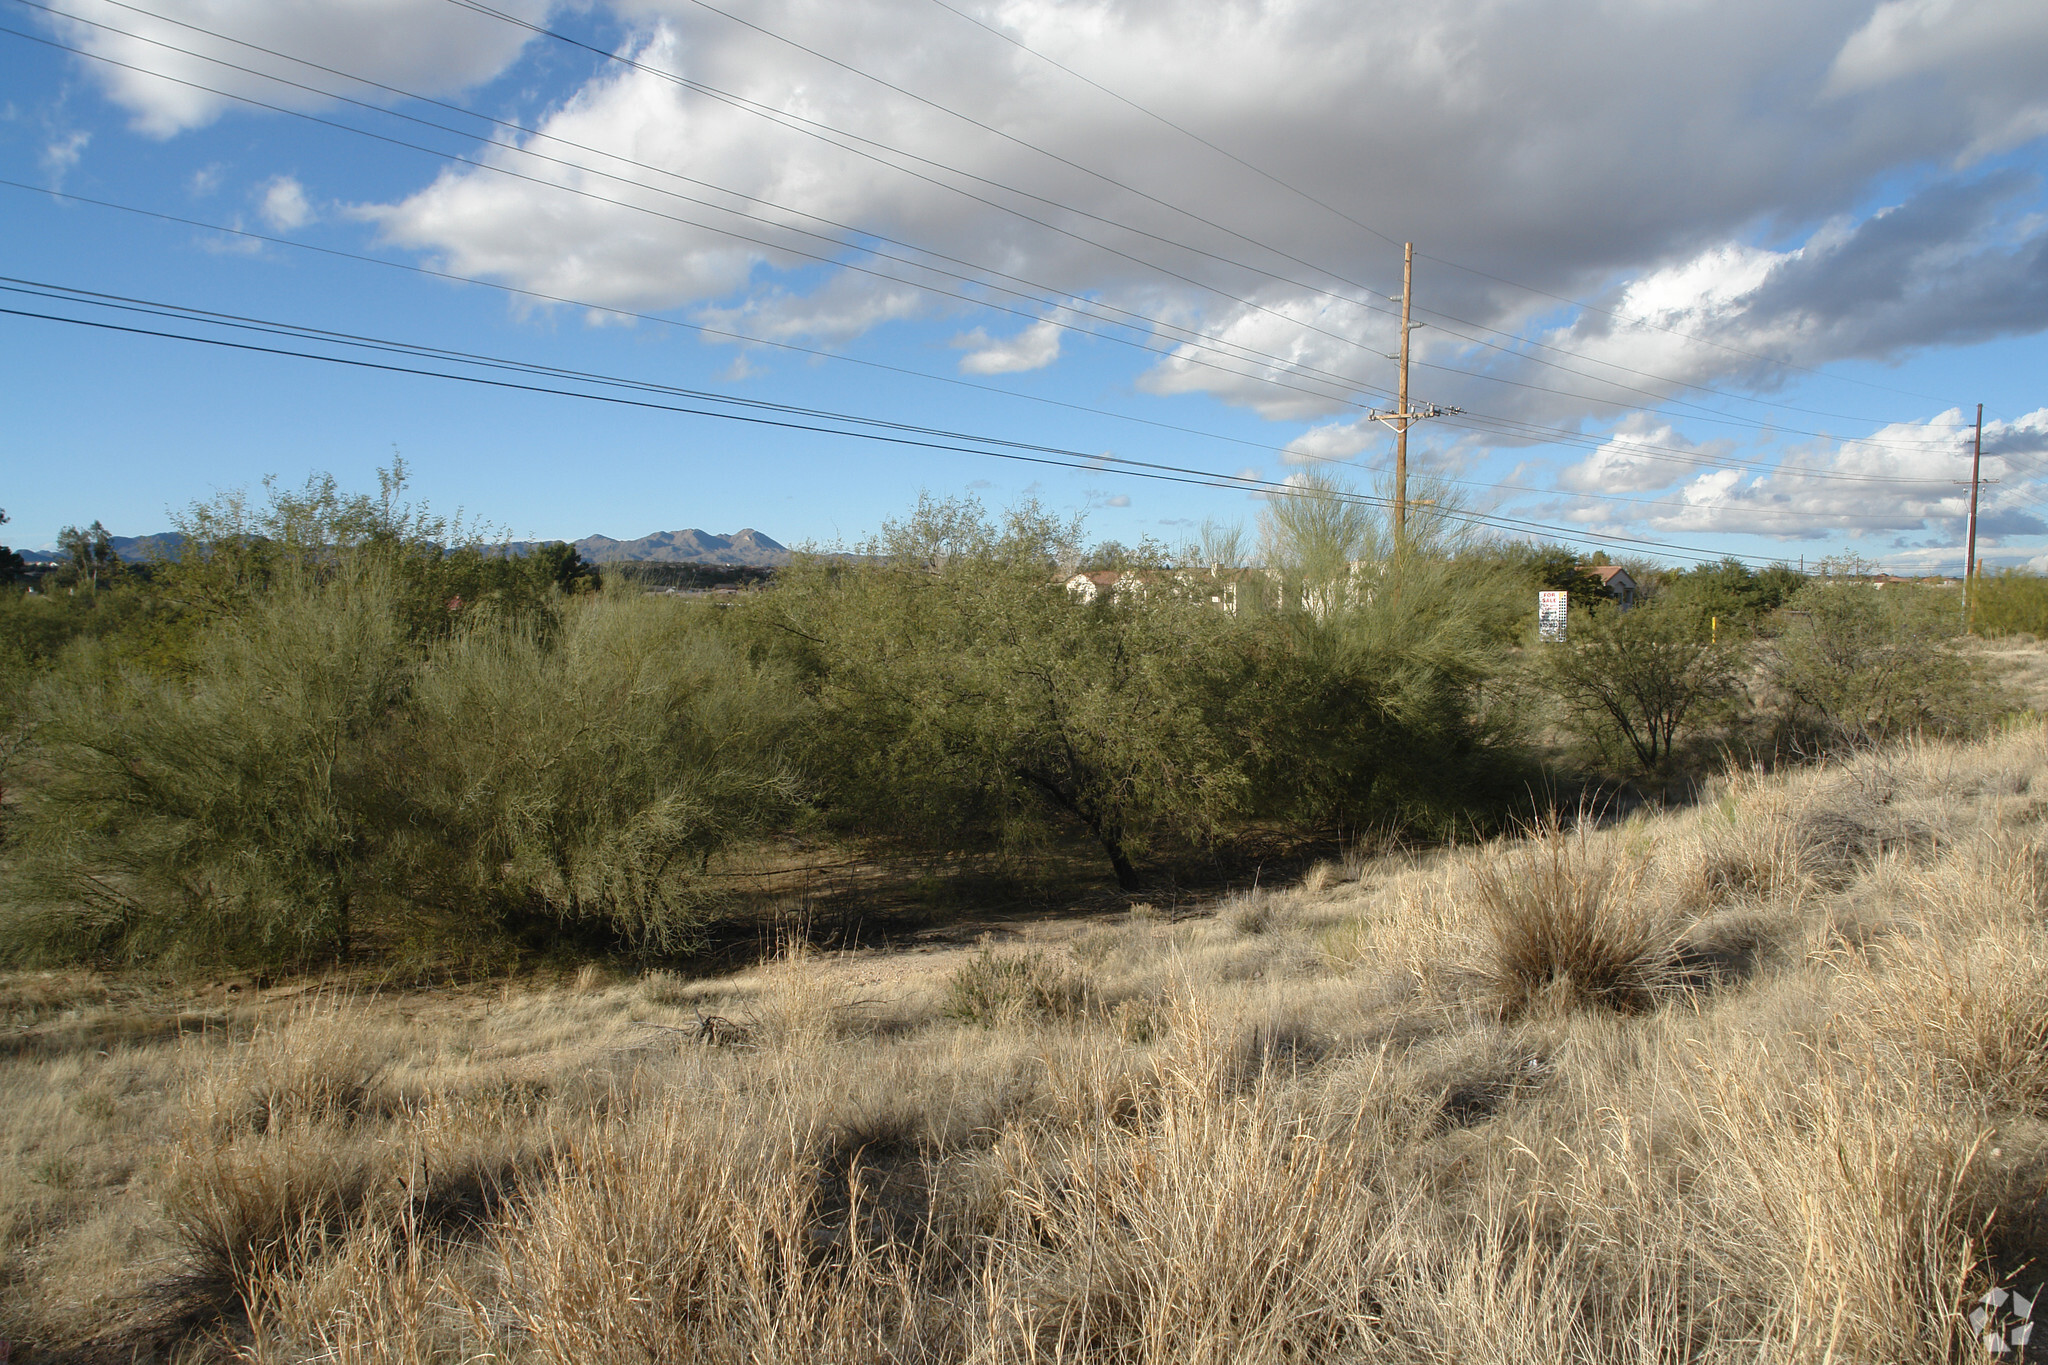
49, 0, 551, 137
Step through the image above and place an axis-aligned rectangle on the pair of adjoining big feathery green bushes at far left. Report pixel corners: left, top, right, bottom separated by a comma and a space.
0, 559, 795, 962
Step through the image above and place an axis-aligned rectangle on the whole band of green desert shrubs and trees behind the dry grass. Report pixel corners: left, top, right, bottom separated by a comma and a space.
19, 469, 2011, 972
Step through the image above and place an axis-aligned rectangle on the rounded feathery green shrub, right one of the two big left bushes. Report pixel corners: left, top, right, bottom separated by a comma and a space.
385, 596, 797, 952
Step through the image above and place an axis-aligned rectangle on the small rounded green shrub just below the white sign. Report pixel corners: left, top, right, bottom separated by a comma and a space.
1534, 593, 1741, 772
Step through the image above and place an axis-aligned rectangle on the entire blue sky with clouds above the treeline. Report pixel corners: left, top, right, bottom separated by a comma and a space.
0, 0, 2048, 571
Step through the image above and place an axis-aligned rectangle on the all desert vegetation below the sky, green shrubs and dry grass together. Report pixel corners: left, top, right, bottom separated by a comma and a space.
0, 471, 2048, 1363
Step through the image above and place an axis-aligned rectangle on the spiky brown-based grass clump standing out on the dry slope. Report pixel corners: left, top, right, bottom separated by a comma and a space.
1473, 821, 1683, 1019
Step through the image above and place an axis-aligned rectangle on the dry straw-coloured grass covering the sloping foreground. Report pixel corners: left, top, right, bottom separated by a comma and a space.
12, 726, 2048, 1365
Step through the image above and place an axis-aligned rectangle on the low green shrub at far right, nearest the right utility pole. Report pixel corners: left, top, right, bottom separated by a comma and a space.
1774, 581, 2001, 749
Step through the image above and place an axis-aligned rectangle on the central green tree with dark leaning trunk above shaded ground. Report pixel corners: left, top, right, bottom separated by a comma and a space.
758, 497, 1245, 888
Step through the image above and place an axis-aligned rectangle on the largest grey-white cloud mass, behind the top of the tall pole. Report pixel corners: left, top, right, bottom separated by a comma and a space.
299, 0, 2015, 394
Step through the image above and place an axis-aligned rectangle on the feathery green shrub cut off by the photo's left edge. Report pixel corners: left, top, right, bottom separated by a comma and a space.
6, 571, 406, 960
